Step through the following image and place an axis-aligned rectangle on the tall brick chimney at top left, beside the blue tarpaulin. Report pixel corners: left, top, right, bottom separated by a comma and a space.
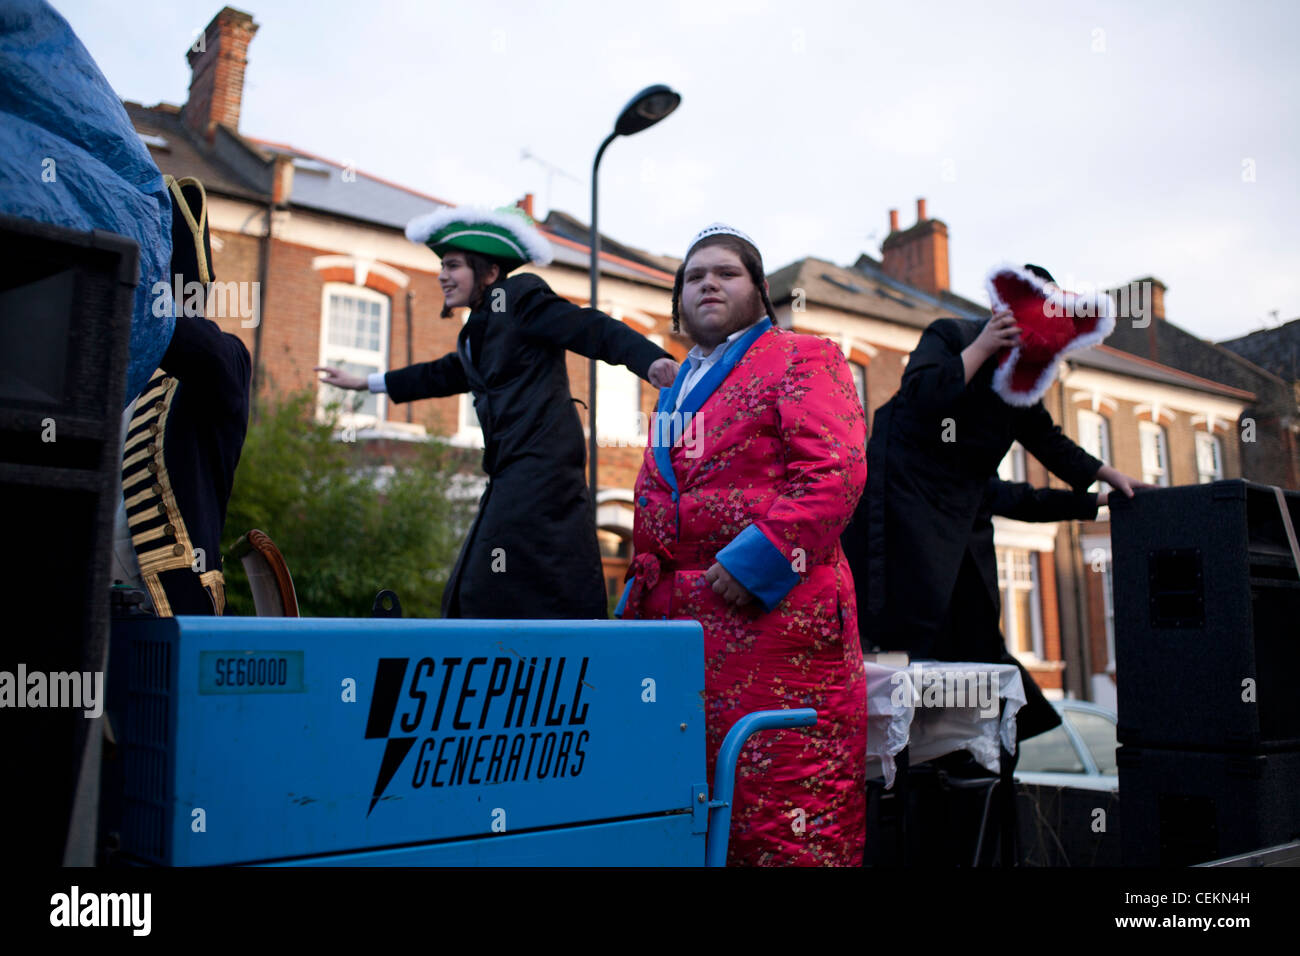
181, 7, 257, 140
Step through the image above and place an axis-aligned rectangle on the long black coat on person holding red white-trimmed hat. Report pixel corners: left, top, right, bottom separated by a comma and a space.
844, 319, 1101, 659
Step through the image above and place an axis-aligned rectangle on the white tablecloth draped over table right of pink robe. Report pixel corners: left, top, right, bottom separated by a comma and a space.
866, 661, 1024, 787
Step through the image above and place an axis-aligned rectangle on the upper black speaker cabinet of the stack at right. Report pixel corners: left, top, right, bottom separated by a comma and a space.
1110, 480, 1300, 753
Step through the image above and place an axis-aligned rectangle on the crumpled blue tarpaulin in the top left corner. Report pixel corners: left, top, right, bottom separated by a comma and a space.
0, 0, 176, 402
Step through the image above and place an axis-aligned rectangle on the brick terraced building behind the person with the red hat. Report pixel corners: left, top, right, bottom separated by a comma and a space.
770, 199, 1255, 708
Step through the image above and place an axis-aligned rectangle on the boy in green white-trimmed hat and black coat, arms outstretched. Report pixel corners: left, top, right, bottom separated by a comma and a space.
319, 207, 677, 619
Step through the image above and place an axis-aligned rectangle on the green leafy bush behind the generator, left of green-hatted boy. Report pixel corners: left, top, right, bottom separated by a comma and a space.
221, 390, 472, 618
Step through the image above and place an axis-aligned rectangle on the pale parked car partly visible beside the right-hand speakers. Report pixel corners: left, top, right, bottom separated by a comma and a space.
1015, 700, 1119, 792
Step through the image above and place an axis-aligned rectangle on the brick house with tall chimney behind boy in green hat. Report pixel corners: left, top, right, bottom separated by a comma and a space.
125, 7, 689, 600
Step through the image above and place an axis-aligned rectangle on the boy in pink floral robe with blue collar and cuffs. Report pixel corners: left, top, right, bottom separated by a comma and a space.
616, 225, 867, 865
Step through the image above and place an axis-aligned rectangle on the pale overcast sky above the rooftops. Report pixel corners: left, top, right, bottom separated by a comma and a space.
55, 0, 1300, 339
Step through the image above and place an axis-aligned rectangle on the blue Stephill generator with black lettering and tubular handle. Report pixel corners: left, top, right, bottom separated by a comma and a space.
101, 618, 816, 866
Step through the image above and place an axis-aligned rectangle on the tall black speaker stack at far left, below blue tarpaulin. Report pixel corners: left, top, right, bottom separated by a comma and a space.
0, 216, 139, 864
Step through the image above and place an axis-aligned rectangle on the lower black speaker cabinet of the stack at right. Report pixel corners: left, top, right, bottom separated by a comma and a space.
1118, 747, 1300, 866
